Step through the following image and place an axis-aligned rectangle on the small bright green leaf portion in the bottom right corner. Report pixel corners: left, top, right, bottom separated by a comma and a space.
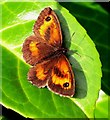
95, 90, 109, 118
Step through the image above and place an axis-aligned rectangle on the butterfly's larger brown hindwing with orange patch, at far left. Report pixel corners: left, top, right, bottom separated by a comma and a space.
22, 36, 54, 65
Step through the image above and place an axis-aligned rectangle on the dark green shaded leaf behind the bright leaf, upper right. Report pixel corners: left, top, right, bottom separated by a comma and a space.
60, 2, 110, 95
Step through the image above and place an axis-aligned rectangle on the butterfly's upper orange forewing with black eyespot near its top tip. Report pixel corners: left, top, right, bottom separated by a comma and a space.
34, 7, 62, 48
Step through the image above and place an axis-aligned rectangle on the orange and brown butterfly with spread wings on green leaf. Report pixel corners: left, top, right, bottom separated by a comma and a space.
22, 7, 75, 97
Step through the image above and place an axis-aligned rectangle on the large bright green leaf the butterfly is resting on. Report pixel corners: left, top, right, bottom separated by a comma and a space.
0, 2, 101, 118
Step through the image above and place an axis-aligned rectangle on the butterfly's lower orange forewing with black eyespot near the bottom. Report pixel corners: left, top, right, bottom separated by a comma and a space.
48, 55, 75, 97
